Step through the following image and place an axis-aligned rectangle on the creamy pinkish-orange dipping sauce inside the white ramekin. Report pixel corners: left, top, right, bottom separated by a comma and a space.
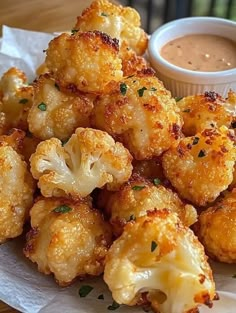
161, 34, 236, 72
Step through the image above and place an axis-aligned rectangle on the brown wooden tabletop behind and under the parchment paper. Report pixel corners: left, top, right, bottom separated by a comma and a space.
0, 0, 120, 313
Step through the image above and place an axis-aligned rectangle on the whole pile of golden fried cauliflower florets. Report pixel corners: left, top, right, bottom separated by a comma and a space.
0, 0, 236, 313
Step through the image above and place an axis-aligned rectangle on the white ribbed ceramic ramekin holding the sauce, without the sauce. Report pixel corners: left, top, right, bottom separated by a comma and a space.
148, 17, 236, 97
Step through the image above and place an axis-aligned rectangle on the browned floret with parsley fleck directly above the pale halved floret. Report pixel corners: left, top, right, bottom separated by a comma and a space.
28, 74, 93, 140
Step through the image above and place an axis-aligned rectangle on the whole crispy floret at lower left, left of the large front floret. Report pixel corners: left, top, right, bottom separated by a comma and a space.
24, 198, 112, 286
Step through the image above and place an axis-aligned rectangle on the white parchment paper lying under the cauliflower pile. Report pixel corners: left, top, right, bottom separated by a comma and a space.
0, 26, 236, 313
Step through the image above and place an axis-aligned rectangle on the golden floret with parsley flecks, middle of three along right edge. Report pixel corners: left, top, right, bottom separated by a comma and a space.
162, 127, 236, 206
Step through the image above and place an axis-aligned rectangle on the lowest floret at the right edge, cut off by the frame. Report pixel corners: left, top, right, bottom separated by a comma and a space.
197, 189, 236, 263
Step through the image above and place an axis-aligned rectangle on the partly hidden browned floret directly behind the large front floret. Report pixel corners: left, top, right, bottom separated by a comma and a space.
97, 175, 197, 236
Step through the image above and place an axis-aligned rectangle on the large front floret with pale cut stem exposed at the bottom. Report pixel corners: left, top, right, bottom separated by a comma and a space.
104, 210, 215, 313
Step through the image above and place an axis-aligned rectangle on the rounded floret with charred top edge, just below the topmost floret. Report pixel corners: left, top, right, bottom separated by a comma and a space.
46, 31, 123, 93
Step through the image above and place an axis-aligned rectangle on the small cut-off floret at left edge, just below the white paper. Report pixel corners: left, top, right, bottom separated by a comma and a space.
0, 67, 33, 134
